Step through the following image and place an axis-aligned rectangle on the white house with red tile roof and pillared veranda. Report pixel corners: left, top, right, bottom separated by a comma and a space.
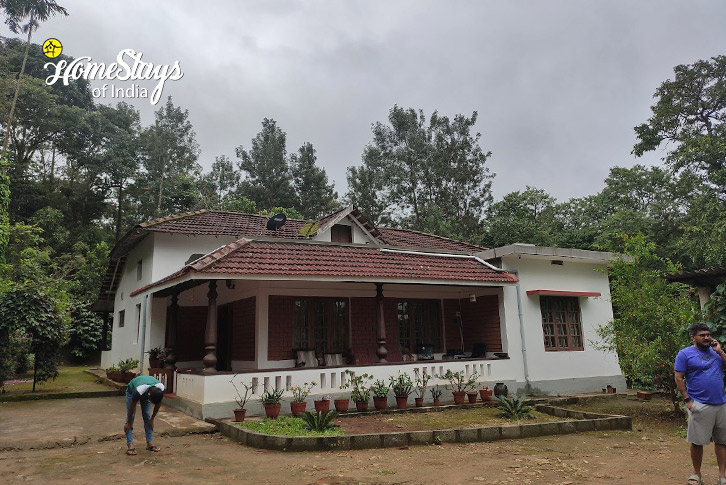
96, 206, 625, 418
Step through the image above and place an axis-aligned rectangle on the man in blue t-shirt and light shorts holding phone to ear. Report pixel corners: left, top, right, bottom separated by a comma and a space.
674, 322, 726, 485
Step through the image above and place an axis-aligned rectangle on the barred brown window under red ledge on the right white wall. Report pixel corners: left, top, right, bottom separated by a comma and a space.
539, 296, 584, 350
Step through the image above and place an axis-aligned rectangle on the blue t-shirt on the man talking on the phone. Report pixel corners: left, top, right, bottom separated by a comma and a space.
675, 345, 726, 406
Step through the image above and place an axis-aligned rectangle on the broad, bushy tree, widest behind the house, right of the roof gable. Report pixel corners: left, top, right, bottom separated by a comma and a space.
347, 106, 493, 240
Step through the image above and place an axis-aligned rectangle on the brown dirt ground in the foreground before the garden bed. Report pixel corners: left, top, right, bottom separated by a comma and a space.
0, 396, 717, 485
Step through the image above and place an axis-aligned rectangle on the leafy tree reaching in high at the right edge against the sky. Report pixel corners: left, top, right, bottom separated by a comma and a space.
633, 56, 726, 191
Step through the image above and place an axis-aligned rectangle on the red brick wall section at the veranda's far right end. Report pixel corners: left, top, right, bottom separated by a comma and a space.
444, 295, 502, 352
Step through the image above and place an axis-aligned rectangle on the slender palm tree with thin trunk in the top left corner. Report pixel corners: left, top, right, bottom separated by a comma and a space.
0, 0, 68, 161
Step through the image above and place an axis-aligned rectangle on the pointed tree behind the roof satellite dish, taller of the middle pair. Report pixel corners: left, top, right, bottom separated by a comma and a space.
236, 118, 295, 210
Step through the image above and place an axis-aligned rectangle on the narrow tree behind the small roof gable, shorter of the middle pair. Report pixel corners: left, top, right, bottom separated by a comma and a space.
290, 143, 338, 219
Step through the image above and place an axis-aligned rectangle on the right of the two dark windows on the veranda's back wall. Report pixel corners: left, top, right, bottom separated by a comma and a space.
398, 300, 441, 352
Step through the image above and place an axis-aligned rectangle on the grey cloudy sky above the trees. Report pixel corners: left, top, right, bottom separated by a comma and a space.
7, 0, 726, 200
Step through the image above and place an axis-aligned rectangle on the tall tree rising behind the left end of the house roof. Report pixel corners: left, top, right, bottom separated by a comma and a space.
136, 96, 201, 217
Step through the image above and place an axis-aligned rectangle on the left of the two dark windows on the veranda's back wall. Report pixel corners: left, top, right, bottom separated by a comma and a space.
293, 298, 348, 354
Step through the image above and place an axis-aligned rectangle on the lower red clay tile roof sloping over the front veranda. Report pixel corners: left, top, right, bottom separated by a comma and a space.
131, 239, 517, 296
